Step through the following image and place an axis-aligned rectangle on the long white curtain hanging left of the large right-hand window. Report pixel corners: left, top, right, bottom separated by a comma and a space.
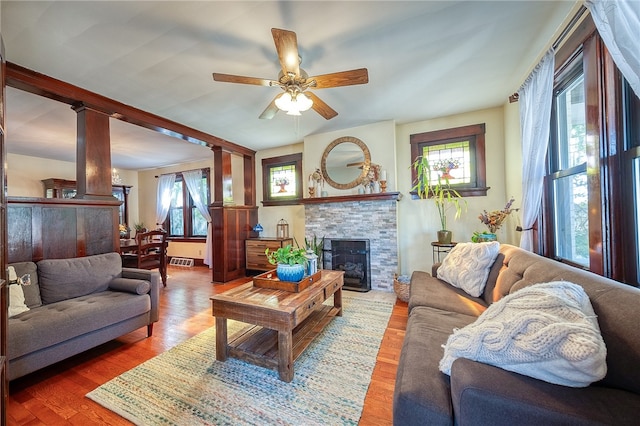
518, 49, 555, 251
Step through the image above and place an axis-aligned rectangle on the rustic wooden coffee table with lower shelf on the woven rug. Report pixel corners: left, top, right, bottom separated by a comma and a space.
211, 270, 344, 382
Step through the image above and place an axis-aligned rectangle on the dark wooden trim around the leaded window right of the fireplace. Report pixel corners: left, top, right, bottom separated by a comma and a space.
409, 123, 490, 199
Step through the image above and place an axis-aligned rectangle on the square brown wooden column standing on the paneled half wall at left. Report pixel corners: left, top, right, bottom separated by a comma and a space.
73, 105, 113, 199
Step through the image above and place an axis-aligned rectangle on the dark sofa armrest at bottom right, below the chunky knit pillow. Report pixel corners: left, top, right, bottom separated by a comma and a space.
451, 358, 640, 426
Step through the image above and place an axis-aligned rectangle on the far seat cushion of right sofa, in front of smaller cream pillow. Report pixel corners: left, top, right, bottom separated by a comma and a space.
409, 271, 487, 317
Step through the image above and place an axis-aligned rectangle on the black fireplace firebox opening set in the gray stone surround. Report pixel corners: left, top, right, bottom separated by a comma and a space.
322, 238, 371, 292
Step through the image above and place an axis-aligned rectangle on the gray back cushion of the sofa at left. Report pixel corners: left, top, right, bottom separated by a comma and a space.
38, 253, 122, 304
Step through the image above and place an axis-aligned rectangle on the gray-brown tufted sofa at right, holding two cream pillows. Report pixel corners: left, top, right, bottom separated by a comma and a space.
393, 244, 640, 426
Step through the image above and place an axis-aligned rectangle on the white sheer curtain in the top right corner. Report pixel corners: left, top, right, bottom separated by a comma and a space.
585, 0, 640, 97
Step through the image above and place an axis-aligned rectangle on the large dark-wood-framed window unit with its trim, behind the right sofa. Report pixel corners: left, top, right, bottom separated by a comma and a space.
538, 16, 640, 286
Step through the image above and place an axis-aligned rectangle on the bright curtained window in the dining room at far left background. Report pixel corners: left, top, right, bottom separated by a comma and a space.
165, 168, 211, 238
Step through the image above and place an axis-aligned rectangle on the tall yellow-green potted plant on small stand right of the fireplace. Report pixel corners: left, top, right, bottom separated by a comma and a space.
411, 156, 467, 244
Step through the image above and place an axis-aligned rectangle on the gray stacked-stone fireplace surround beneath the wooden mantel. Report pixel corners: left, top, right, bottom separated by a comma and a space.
304, 193, 398, 291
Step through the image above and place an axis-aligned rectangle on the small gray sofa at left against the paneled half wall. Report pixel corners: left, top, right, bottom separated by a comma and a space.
7, 253, 160, 380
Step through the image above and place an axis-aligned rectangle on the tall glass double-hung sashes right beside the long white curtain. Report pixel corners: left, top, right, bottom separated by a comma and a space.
548, 70, 589, 267
